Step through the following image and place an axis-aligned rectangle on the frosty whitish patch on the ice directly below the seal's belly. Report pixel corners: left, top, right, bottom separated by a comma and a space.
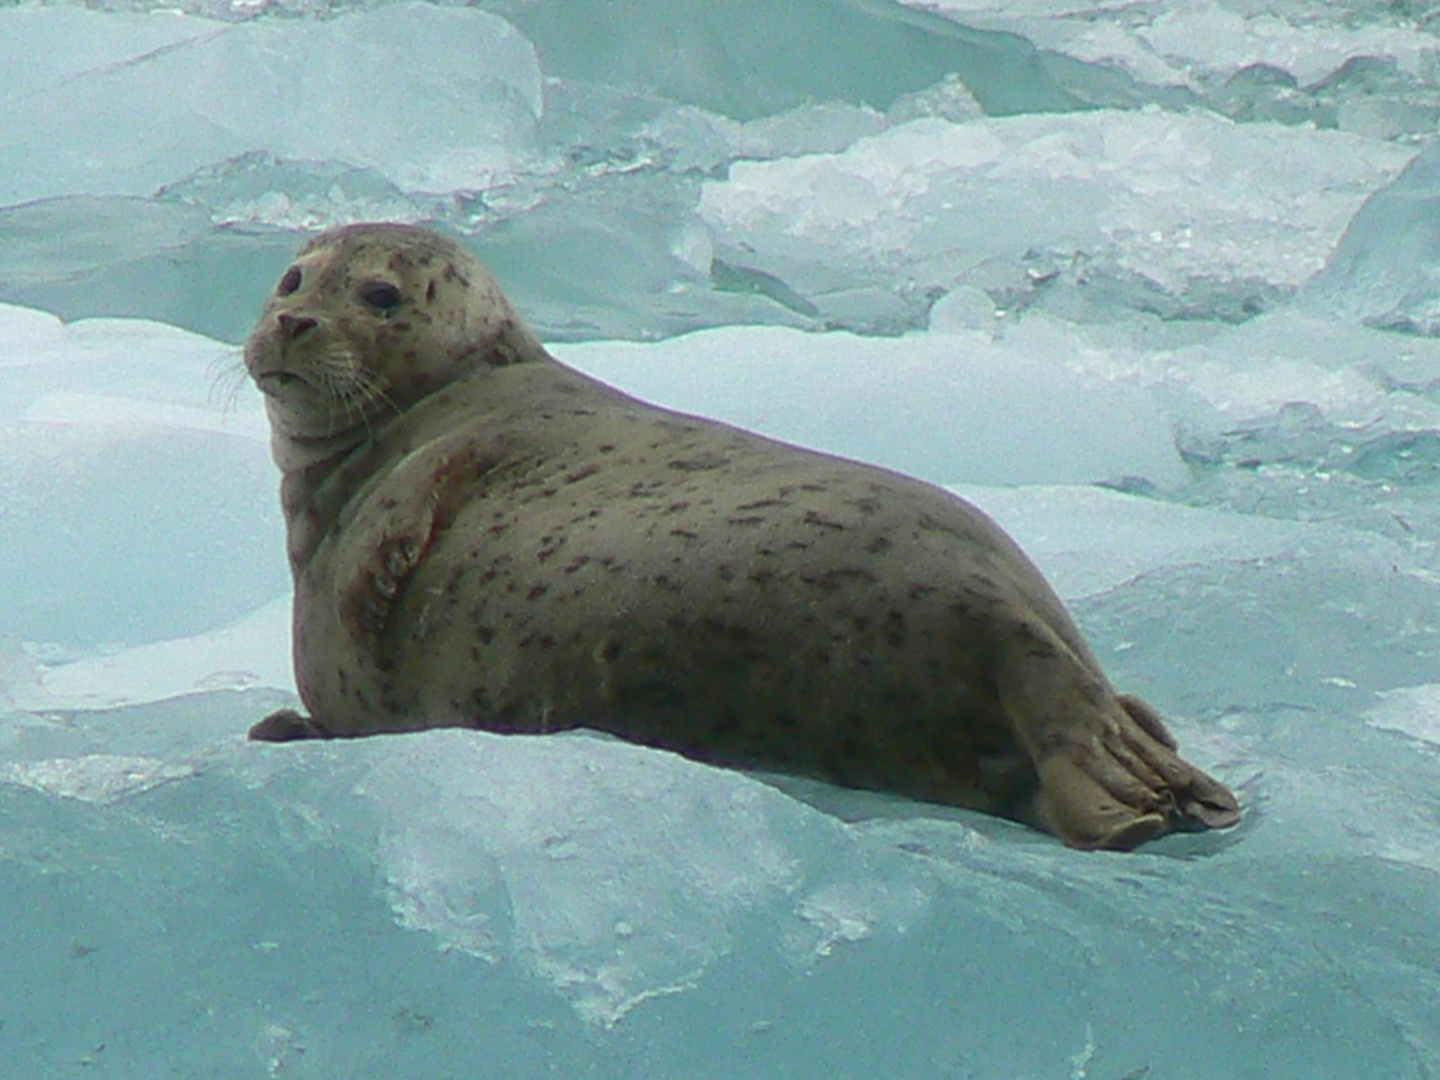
354, 730, 817, 1025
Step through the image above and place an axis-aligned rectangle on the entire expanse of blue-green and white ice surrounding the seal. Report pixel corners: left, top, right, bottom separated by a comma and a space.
0, 0, 1440, 1080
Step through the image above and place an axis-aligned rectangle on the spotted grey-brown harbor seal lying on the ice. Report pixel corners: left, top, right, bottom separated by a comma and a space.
245, 225, 1240, 848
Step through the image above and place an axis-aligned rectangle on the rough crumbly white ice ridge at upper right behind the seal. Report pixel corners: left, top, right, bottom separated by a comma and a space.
700, 109, 1417, 295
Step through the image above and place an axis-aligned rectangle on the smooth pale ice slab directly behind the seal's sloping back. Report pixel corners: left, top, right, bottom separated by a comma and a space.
557, 327, 1182, 484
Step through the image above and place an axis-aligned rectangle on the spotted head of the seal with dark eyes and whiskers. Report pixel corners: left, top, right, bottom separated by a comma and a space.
245, 223, 544, 468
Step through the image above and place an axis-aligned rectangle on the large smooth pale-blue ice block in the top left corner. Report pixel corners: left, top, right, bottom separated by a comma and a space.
0, 3, 541, 203
